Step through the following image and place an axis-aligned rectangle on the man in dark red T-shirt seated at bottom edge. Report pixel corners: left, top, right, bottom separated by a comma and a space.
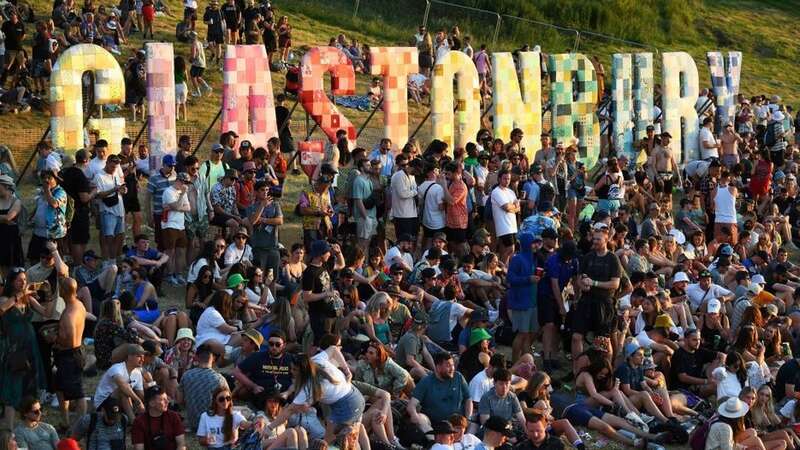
131, 386, 186, 450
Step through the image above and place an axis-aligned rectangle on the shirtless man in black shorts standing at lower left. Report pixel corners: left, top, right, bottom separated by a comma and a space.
53, 278, 86, 427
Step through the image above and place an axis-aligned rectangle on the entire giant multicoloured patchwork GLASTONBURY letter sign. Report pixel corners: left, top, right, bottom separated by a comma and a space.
50, 43, 742, 169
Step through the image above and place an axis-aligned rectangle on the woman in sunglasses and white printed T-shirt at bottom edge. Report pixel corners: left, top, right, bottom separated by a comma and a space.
197, 387, 250, 450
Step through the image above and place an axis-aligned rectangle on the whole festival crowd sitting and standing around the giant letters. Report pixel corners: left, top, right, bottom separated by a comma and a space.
0, 0, 800, 450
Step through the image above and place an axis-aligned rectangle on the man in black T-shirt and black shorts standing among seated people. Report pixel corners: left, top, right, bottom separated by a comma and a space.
572, 224, 622, 370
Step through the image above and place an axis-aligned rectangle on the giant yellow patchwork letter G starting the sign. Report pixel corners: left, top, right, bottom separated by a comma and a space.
50, 44, 125, 152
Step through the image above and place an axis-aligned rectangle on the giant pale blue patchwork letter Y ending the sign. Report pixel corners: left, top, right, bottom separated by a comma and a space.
706, 52, 742, 130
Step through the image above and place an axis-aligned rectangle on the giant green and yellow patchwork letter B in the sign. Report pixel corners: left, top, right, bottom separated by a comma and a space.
550, 53, 600, 167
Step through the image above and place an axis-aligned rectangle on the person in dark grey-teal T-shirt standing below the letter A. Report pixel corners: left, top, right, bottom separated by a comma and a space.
247, 181, 283, 278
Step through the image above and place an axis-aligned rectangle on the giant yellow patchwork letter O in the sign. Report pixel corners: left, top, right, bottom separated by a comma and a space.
431, 51, 481, 152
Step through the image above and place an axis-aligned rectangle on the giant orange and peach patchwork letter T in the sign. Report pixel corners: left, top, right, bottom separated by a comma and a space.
370, 47, 419, 152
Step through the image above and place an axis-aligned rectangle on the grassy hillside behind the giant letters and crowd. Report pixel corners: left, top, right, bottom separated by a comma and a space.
0, 0, 800, 169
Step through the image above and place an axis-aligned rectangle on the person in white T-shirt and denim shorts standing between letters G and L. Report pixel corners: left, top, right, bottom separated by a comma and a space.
94, 155, 128, 262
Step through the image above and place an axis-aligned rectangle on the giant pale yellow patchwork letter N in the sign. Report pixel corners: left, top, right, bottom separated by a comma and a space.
492, 52, 542, 160
